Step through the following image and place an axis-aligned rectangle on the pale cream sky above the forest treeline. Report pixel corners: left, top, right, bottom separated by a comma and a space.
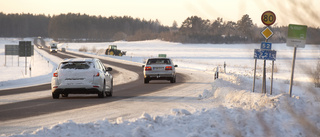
0, 0, 320, 27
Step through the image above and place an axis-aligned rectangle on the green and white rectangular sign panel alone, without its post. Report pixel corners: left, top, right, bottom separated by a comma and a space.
287, 24, 307, 48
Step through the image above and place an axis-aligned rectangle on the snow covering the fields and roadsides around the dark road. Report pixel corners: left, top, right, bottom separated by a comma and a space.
0, 38, 320, 137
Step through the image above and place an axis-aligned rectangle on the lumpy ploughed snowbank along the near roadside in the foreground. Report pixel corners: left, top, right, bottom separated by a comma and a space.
5, 74, 320, 137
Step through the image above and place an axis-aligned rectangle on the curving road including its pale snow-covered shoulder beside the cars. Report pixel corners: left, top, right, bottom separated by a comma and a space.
0, 41, 212, 134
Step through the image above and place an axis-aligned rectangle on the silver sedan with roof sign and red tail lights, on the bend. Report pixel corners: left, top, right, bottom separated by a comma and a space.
142, 58, 178, 83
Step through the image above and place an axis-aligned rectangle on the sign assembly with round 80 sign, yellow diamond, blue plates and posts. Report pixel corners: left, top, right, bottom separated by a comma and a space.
252, 11, 277, 94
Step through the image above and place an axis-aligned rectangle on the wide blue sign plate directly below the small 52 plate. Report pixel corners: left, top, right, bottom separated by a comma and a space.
254, 49, 277, 60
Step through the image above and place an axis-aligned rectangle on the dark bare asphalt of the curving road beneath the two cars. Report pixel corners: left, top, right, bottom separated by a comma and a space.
0, 38, 187, 122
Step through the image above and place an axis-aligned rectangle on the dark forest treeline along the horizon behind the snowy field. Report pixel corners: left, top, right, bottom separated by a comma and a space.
0, 13, 320, 44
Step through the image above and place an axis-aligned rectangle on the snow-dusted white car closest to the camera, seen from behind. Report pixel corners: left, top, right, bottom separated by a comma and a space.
51, 58, 113, 99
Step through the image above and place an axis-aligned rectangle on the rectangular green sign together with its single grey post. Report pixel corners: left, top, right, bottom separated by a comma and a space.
287, 24, 307, 97
